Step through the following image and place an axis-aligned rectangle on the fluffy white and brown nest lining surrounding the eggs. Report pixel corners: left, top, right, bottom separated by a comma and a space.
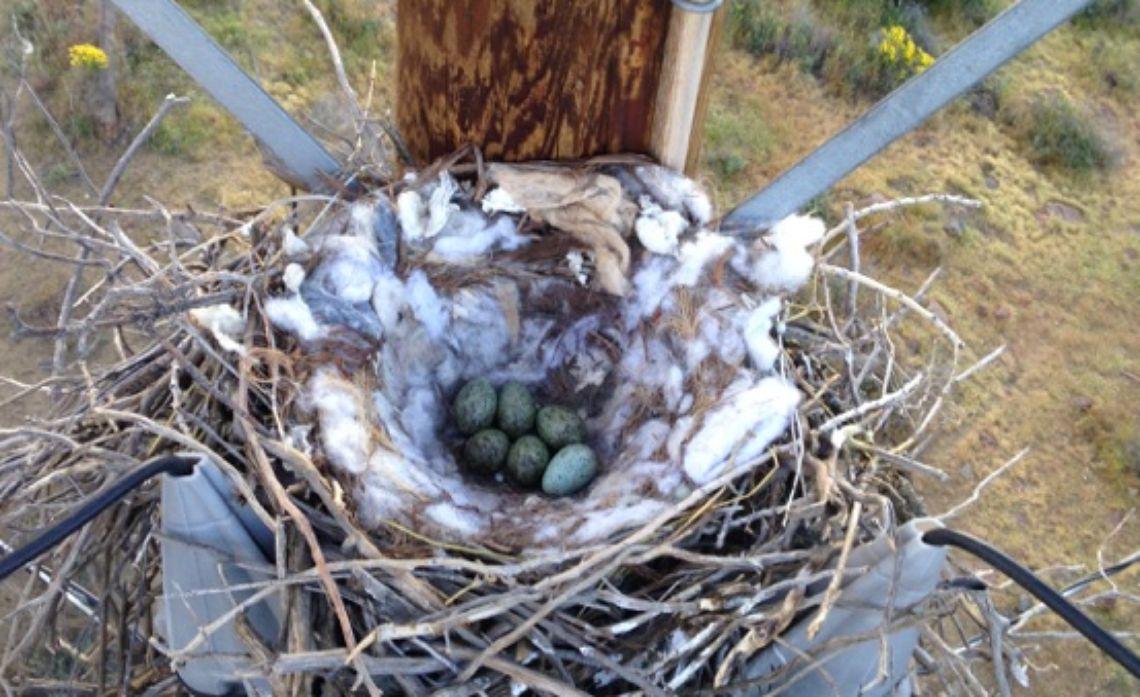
267, 165, 823, 550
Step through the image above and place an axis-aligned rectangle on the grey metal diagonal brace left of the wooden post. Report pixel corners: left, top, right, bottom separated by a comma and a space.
111, 0, 341, 191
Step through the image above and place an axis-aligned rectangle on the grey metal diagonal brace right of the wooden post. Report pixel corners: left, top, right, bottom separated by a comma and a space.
724, 0, 1091, 230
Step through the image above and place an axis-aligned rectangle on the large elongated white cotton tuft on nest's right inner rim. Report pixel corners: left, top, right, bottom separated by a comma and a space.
684, 378, 799, 484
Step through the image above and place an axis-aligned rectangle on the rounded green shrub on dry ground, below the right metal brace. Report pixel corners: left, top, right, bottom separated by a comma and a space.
1025, 92, 1114, 172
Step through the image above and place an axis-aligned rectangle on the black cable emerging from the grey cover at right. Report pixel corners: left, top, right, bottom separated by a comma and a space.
922, 528, 1140, 679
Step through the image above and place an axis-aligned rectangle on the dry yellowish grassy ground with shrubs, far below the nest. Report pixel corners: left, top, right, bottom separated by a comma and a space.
0, 0, 1140, 695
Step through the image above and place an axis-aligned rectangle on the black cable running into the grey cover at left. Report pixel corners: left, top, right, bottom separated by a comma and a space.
0, 455, 198, 581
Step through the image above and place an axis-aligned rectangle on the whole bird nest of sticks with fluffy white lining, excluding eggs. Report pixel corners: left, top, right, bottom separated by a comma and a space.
0, 146, 1016, 694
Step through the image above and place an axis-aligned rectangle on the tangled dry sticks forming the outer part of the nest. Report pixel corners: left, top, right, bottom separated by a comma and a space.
0, 146, 1007, 695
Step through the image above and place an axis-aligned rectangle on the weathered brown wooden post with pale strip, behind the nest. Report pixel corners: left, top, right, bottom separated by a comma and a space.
396, 0, 723, 169
